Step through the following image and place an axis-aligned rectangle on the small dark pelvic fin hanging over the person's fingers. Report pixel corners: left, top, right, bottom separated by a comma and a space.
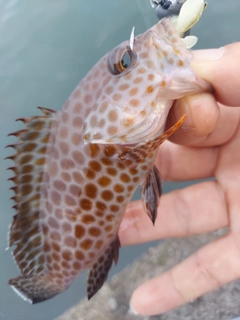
141, 166, 162, 224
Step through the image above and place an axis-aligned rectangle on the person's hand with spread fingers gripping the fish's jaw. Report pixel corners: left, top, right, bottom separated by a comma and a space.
119, 43, 240, 315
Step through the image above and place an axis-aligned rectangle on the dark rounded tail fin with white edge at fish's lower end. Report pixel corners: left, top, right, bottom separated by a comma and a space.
8, 274, 68, 304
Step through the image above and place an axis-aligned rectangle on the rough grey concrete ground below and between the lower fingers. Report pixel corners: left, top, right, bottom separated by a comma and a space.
56, 230, 240, 320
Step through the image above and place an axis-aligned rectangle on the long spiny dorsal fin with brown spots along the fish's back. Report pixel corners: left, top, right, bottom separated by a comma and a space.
7, 107, 57, 276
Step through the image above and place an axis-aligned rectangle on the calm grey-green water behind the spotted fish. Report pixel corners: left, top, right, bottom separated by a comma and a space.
0, 0, 240, 320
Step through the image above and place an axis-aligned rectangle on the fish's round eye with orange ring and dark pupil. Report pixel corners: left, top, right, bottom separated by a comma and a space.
107, 46, 136, 75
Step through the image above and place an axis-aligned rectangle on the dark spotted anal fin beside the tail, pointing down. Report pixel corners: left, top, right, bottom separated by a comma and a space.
87, 236, 120, 299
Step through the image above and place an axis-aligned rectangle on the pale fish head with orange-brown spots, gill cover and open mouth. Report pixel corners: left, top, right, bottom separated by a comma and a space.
84, 18, 209, 144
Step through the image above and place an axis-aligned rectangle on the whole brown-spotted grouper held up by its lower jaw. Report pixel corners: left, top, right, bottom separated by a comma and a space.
8, 18, 210, 304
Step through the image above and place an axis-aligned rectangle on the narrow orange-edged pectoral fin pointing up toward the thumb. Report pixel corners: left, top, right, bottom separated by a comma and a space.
119, 114, 187, 163
